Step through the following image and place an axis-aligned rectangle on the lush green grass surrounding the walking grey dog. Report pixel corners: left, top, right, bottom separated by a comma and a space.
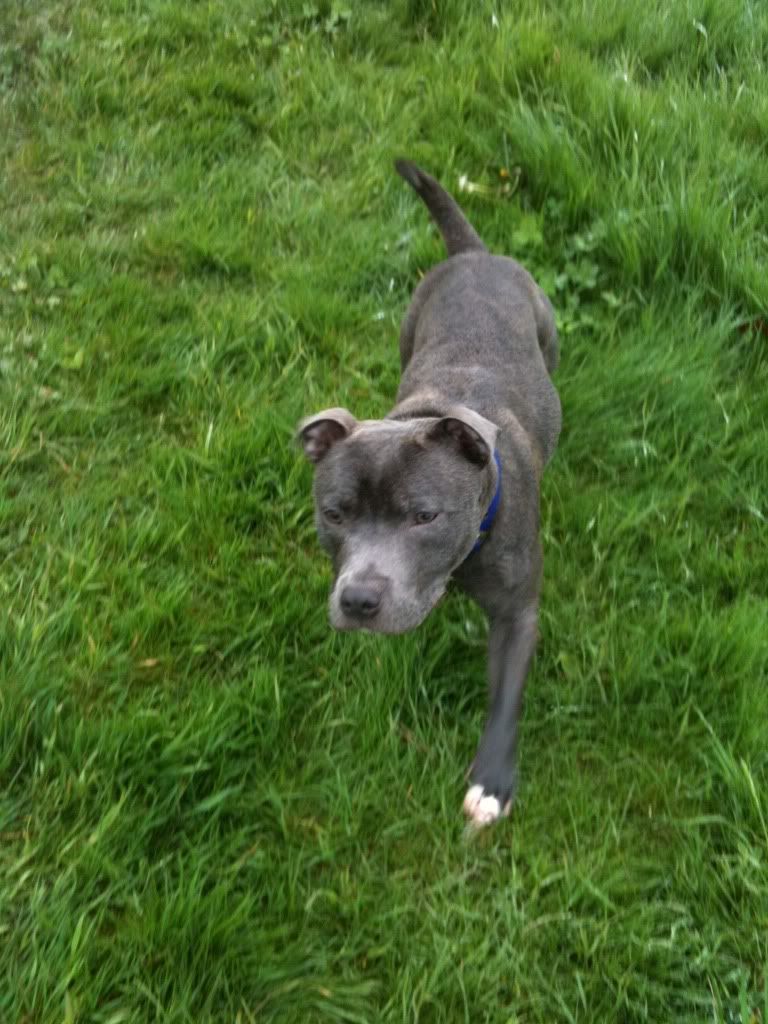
0, 0, 768, 1024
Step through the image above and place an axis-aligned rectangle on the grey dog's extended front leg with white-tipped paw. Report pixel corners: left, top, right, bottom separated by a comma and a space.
464, 604, 538, 826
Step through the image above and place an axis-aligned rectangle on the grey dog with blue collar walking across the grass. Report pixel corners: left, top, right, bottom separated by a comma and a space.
299, 160, 560, 825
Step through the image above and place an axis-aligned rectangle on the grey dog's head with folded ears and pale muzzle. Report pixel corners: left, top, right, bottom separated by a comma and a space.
299, 407, 497, 633
